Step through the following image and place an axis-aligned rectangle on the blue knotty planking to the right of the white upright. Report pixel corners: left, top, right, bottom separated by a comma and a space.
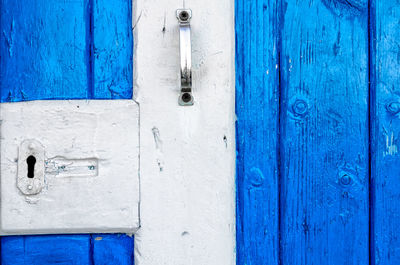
235, 0, 400, 265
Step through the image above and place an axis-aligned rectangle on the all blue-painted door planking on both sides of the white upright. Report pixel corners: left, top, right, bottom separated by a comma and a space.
0, 0, 400, 265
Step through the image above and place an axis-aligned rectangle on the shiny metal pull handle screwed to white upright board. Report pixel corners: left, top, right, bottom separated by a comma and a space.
176, 9, 193, 106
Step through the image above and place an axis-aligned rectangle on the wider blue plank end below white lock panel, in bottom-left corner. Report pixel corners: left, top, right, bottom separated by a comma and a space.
1, 235, 93, 265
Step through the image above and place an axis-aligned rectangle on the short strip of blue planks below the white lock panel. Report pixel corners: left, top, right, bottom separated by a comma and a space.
1, 234, 134, 265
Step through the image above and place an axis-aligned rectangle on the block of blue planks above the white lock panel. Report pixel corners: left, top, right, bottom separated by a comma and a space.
0, 0, 133, 102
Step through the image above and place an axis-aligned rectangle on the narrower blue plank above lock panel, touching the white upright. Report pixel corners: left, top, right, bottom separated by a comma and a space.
92, 0, 133, 99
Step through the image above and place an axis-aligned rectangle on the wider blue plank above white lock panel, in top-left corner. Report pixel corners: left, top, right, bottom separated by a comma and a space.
0, 0, 90, 102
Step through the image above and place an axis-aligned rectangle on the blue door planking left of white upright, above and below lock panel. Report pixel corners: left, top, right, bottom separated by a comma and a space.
0, 0, 133, 265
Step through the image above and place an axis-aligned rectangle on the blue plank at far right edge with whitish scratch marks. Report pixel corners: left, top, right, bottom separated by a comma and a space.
370, 0, 400, 264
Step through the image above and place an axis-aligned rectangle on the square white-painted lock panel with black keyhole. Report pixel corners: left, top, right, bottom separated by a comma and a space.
0, 100, 139, 234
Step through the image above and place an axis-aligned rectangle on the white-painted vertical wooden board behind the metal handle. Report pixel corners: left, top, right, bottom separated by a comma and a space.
133, 0, 235, 265
